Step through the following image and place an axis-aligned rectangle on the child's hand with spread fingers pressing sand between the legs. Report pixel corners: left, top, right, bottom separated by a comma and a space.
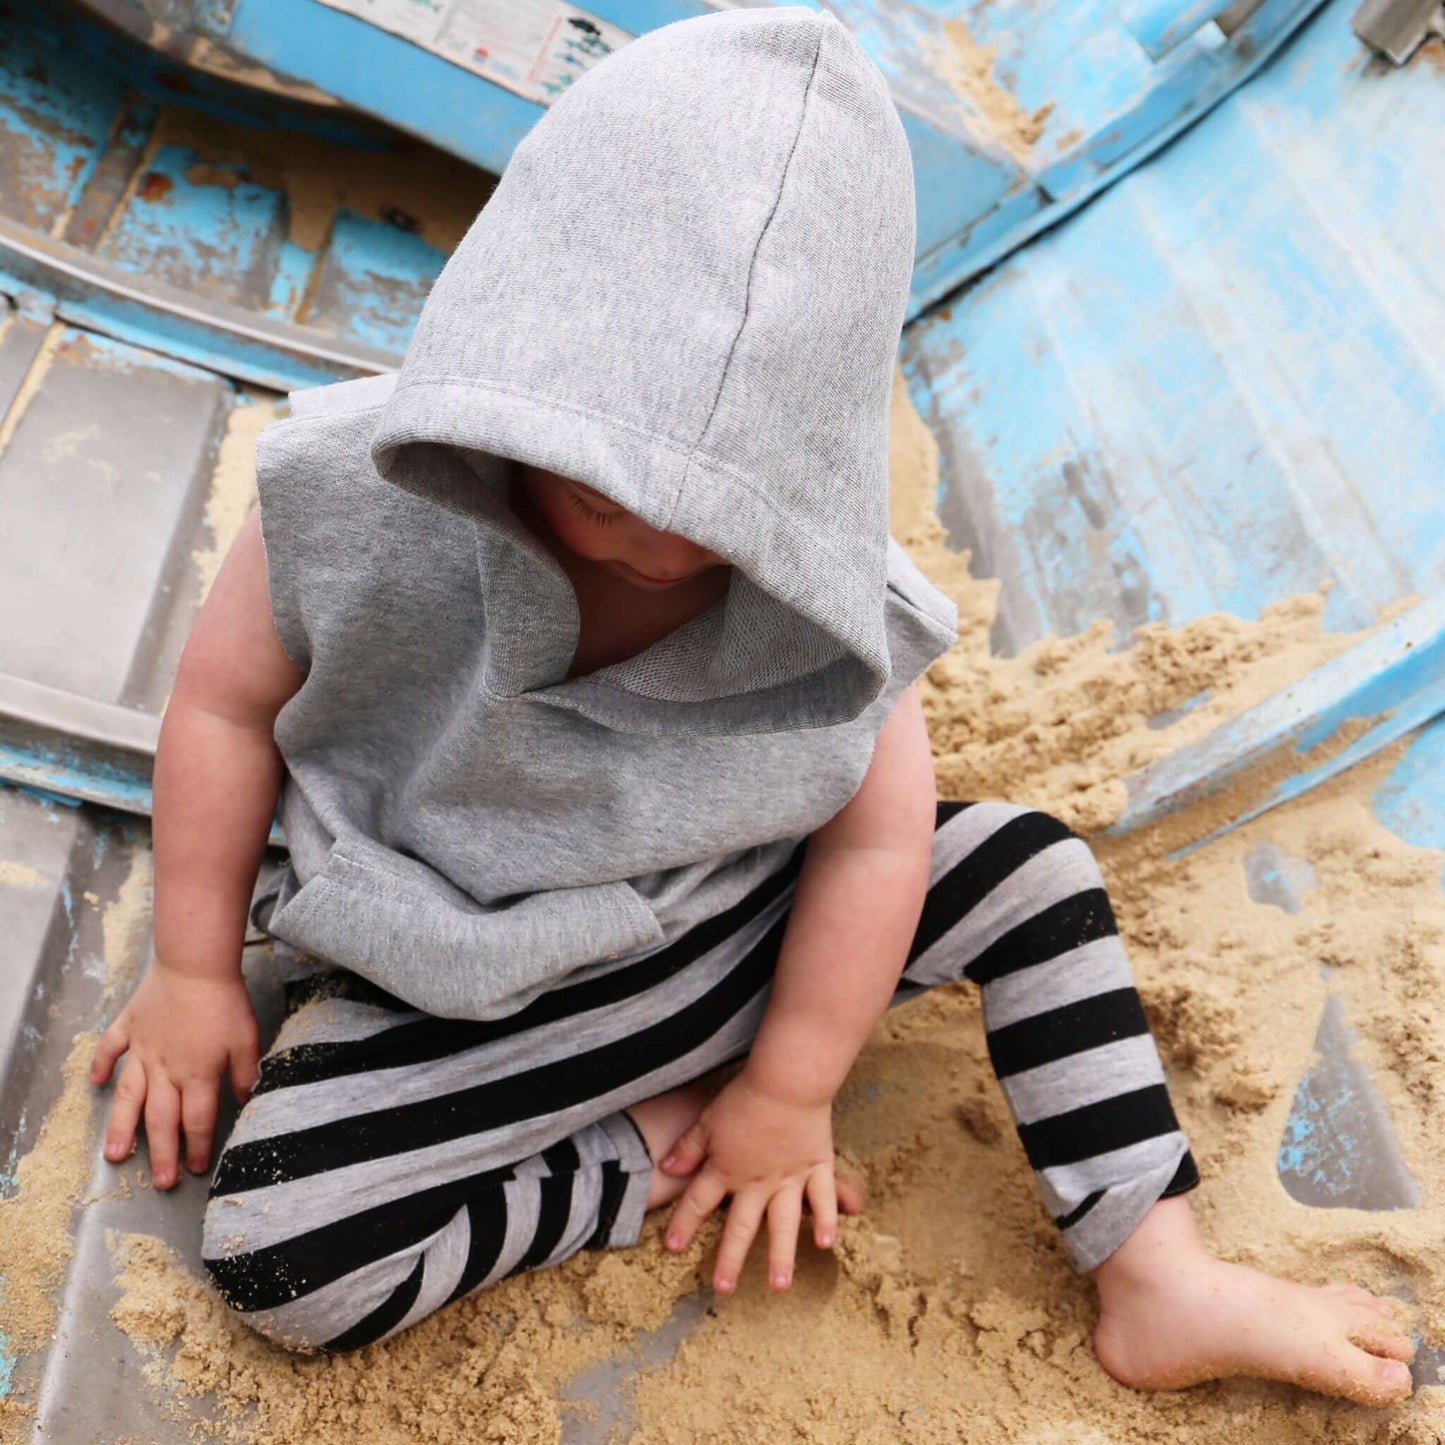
662, 1069, 838, 1295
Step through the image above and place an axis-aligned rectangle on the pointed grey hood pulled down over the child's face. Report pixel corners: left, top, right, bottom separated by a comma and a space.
371, 6, 913, 731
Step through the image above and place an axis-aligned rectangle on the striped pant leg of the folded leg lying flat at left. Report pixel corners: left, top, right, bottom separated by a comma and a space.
201, 854, 801, 1350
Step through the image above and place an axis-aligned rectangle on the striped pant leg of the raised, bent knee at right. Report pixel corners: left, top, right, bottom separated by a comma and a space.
899, 803, 1199, 1270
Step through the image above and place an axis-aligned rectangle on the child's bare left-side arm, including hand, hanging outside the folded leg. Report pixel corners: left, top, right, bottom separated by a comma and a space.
91, 513, 303, 1188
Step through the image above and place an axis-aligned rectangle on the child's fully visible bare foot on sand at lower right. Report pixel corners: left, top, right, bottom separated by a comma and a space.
1094, 1198, 1415, 1405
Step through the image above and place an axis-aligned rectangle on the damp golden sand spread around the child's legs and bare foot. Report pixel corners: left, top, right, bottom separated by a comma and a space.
0, 375, 1445, 1445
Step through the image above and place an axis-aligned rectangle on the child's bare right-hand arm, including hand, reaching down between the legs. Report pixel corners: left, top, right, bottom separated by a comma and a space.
663, 688, 936, 1292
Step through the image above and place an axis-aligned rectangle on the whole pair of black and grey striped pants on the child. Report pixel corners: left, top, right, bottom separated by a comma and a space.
202, 803, 1198, 1350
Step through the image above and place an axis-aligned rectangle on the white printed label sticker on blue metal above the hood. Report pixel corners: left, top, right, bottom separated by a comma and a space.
321, 0, 631, 105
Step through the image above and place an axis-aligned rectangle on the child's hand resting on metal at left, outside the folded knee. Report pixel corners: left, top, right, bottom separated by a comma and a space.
91, 959, 260, 1189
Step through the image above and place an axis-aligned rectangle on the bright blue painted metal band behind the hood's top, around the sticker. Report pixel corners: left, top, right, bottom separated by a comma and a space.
65, 0, 1319, 312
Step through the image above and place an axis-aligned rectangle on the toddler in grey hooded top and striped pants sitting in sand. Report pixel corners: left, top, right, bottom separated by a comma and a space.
92, 7, 1412, 1405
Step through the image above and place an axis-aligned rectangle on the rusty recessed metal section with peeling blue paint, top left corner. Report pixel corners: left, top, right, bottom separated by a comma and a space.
0, 0, 494, 387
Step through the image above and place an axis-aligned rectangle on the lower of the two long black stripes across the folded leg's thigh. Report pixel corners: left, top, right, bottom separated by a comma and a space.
211, 913, 788, 1195
